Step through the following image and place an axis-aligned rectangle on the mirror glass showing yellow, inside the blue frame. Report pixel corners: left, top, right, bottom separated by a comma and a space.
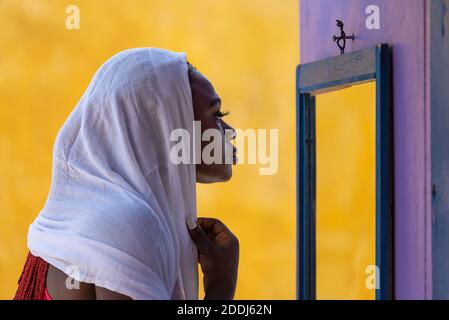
316, 83, 376, 299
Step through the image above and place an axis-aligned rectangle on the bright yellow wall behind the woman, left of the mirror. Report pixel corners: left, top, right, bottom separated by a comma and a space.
0, 0, 299, 299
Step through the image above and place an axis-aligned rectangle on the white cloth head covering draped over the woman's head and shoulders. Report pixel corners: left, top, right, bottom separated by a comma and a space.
28, 48, 198, 299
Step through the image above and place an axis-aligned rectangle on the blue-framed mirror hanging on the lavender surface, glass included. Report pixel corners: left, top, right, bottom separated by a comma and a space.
296, 44, 394, 300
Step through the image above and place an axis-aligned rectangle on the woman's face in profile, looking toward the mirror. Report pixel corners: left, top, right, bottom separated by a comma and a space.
189, 69, 237, 183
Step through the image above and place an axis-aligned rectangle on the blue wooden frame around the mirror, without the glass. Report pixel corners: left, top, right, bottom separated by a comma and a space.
296, 44, 394, 300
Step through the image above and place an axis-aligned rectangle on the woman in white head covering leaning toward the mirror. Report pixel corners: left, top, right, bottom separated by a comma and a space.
15, 48, 239, 299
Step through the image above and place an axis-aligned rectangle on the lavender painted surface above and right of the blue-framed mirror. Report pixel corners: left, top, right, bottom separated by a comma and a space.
300, 0, 432, 299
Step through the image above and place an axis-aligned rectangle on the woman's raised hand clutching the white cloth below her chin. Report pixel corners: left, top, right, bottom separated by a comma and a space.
187, 217, 239, 300
